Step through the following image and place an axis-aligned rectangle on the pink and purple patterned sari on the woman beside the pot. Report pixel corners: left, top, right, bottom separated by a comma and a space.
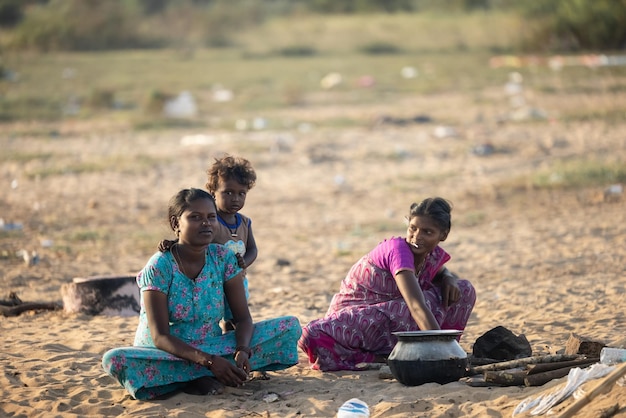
298, 238, 476, 371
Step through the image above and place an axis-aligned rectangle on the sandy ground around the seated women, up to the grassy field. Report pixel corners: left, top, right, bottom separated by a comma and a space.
0, 90, 626, 417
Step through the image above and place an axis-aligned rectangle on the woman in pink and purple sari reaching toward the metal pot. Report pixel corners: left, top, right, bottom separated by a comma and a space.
298, 197, 476, 371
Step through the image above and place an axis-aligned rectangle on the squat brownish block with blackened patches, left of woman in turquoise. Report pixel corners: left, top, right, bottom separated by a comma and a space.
61, 275, 140, 316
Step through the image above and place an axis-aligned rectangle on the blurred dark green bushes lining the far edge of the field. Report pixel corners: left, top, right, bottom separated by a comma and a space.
0, 0, 626, 52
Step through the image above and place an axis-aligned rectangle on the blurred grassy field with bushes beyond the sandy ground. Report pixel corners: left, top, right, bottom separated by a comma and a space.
0, 0, 626, 125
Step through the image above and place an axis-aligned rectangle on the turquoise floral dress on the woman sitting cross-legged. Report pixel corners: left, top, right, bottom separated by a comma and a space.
102, 244, 302, 399
